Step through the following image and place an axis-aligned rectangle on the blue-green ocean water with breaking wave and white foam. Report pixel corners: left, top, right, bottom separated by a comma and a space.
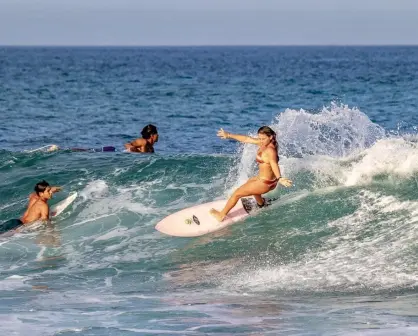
0, 47, 418, 336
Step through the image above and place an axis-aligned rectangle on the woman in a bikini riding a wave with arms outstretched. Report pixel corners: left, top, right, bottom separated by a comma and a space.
210, 126, 292, 222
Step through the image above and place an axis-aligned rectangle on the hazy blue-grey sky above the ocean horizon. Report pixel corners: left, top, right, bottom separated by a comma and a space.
0, 0, 418, 45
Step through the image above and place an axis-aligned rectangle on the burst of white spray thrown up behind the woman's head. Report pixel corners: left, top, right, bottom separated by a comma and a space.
272, 103, 385, 157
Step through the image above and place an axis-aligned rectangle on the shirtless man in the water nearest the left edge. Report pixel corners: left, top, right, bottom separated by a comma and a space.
0, 180, 61, 233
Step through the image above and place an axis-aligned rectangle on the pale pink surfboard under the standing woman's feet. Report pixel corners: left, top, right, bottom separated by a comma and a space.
155, 198, 271, 237
